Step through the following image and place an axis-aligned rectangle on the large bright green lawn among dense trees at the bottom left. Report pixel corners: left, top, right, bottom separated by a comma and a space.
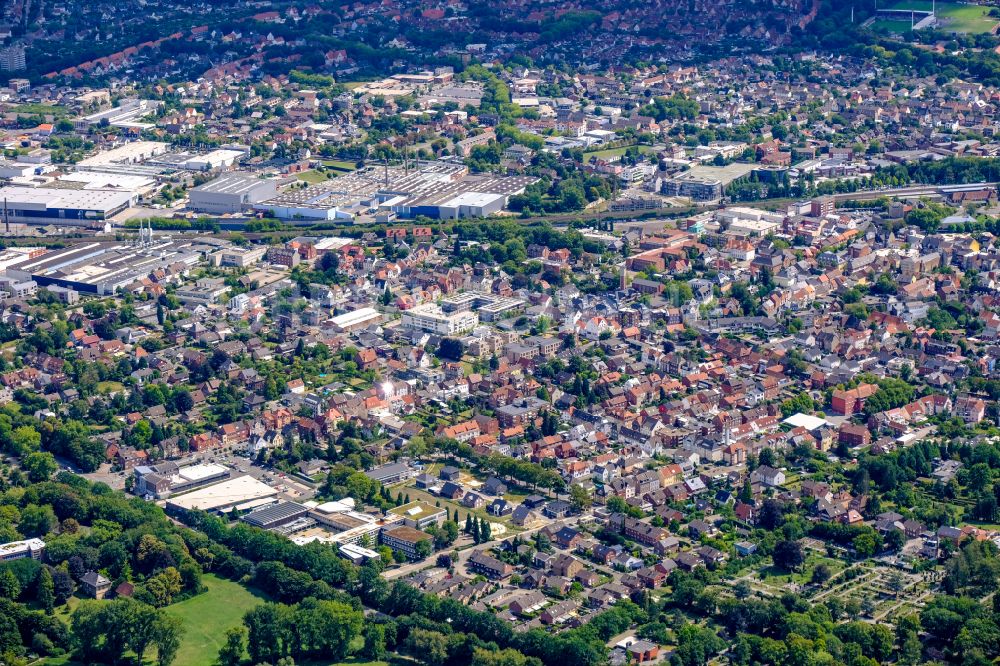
166, 574, 264, 666
